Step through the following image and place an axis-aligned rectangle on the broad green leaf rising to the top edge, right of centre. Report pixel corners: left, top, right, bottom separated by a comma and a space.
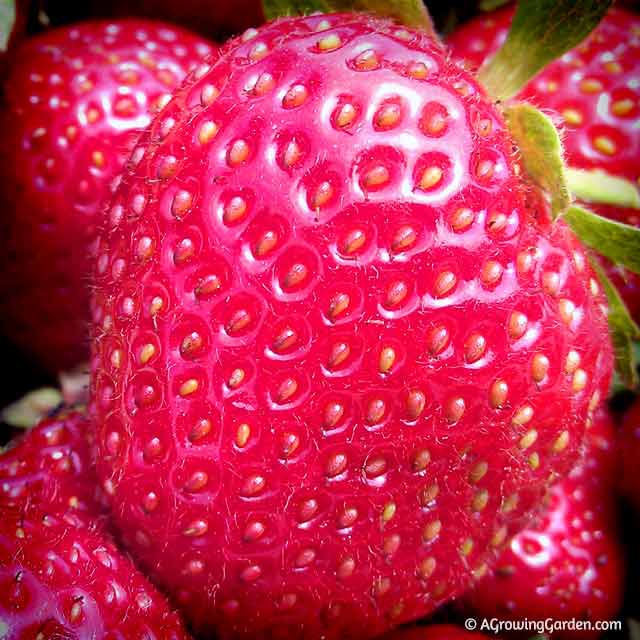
478, 0, 612, 100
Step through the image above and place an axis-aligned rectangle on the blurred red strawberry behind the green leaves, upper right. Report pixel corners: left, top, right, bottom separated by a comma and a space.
448, 6, 640, 319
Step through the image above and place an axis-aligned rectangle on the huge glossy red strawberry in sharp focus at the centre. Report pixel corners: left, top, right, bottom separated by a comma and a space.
92, 14, 611, 638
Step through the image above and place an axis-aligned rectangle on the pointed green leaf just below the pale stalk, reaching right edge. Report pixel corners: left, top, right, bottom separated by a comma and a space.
564, 205, 640, 273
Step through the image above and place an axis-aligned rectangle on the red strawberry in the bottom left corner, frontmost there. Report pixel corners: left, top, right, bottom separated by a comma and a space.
0, 508, 188, 640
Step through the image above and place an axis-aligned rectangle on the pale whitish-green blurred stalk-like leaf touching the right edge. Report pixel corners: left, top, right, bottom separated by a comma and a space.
565, 168, 640, 209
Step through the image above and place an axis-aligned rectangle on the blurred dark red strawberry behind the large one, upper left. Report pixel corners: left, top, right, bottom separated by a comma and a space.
0, 21, 215, 371
